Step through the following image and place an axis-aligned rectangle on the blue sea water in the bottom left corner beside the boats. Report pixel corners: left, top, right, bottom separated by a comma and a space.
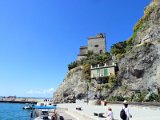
0, 103, 32, 120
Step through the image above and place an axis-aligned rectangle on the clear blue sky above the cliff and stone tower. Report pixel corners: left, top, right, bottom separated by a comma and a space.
0, 0, 151, 97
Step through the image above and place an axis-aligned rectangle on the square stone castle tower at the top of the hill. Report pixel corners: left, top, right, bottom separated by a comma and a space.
88, 33, 106, 54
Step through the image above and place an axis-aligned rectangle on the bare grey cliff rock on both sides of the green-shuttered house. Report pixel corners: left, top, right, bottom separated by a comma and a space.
54, 0, 160, 101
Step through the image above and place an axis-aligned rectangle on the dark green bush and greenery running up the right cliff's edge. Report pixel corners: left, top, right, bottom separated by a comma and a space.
111, 3, 157, 60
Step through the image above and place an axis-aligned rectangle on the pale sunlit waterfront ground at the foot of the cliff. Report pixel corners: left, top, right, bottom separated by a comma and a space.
57, 102, 160, 120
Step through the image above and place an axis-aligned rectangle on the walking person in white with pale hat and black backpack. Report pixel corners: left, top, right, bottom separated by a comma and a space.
122, 100, 132, 120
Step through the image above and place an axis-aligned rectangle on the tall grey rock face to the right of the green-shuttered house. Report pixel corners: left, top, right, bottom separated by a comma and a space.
111, 2, 160, 96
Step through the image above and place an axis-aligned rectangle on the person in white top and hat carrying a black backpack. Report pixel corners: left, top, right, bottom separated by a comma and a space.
120, 100, 132, 120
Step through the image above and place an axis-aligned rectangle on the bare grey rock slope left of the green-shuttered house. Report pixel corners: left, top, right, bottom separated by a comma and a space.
54, 66, 95, 102
